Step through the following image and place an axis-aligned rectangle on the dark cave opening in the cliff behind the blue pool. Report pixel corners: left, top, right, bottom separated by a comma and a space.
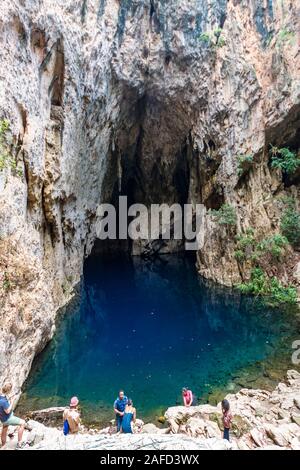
91, 97, 192, 258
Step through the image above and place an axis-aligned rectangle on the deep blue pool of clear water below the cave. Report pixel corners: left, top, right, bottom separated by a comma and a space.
20, 255, 295, 424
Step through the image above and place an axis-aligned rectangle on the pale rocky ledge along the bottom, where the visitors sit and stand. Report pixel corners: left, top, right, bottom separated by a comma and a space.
3, 370, 300, 450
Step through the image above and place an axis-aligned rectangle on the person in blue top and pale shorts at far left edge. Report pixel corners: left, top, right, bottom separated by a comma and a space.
0, 383, 25, 448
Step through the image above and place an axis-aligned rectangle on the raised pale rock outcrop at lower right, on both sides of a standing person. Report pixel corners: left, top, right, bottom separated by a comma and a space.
165, 370, 300, 450
